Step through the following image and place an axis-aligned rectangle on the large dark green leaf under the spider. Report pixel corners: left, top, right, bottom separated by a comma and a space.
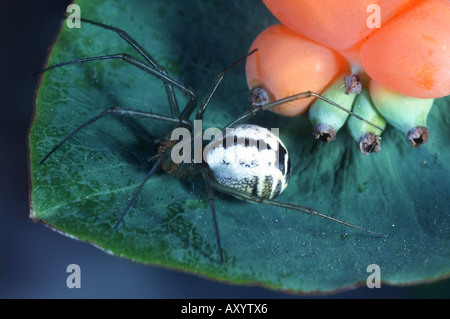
29, 0, 450, 292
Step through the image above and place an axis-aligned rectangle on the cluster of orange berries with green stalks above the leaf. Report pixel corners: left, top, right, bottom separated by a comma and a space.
246, 0, 450, 154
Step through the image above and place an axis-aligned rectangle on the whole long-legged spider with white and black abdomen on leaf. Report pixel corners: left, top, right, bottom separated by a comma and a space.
37, 18, 387, 264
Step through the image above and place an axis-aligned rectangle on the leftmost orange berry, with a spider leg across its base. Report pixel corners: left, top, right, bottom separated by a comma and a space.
246, 24, 350, 116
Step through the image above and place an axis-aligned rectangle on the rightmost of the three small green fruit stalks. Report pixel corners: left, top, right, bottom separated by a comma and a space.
370, 80, 434, 147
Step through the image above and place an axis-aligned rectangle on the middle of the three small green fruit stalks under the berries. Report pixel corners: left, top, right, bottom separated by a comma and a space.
347, 89, 386, 155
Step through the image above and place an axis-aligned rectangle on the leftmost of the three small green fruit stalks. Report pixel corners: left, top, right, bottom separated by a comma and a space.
309, 76, 356, 142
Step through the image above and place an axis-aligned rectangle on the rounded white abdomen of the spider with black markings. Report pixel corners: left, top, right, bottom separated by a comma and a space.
205, 124, 291, 199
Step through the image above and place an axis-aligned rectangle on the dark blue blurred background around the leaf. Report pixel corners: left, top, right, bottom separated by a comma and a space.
0, 0, 450, 298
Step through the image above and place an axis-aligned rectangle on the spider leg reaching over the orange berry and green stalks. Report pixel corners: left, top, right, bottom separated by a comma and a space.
225, 91, 383, 132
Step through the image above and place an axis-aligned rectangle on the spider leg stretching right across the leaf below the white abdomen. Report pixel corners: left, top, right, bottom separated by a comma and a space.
210, 180, 388, 238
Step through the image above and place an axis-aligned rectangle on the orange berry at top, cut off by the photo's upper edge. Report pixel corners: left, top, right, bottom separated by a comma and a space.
263, 0, 419, 52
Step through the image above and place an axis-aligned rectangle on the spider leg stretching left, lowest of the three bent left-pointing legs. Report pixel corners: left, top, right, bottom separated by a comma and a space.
39, 107, 192, 164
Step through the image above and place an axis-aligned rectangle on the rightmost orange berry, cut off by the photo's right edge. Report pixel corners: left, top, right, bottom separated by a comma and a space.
361, 0, 450, 99
